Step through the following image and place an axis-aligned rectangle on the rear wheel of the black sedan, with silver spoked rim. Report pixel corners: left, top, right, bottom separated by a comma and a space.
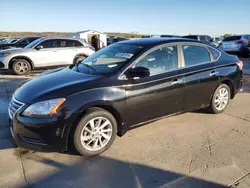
209, 84, 231, 114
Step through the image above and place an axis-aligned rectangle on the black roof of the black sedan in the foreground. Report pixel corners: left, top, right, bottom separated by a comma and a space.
118, 37, 204, 46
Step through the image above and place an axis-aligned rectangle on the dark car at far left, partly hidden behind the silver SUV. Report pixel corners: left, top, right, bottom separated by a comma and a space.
0, 37, 40, 50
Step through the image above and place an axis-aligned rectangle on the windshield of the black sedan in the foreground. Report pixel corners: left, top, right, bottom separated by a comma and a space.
72, 43, 144, 74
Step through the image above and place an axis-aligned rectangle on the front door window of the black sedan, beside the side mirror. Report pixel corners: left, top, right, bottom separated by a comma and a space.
136, 46, 178, 75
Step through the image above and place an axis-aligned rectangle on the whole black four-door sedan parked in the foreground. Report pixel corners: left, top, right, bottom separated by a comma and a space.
9, 38, 243, 156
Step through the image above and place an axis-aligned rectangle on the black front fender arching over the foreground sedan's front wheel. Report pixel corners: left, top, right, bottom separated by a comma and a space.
61, 86, 127, 147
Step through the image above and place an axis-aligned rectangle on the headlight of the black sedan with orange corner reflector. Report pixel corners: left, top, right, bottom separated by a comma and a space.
22, 98, 66, 117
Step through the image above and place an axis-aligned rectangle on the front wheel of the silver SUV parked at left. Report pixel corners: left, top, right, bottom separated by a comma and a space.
11, 59, 31, 75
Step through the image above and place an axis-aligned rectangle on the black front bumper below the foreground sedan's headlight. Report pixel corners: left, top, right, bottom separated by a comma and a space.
10, 113, 68, 151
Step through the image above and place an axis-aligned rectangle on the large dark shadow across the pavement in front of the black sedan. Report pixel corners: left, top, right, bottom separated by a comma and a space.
22, 153, 229, 188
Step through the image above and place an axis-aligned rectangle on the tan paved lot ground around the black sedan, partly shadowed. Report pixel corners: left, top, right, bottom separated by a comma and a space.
0, 60, 250, 188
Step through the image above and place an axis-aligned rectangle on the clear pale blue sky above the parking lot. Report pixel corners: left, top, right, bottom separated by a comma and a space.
0, 0, 250, 35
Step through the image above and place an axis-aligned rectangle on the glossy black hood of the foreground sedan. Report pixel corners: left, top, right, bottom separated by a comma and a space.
14, 67, 103, 104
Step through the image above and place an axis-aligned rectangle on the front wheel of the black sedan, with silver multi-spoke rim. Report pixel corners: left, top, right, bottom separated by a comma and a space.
74, 108, 117, 156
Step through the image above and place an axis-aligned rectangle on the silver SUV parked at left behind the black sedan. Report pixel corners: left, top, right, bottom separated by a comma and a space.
0, 37, 95, 75
